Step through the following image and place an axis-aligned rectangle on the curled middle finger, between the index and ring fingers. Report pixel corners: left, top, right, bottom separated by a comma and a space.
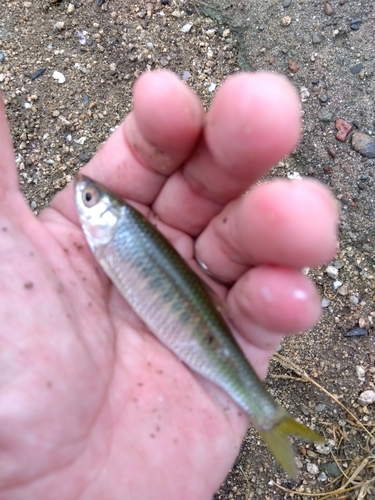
153, 72, 300, 235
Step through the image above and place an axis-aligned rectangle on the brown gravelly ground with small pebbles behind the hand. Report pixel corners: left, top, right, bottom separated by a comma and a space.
0, 0, 375, 500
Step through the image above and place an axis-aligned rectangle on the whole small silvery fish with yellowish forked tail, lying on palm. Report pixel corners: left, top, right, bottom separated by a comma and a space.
74, 174, 324, 478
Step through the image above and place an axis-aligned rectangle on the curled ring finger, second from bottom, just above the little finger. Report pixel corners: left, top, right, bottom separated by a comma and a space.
195, 179, 338, 282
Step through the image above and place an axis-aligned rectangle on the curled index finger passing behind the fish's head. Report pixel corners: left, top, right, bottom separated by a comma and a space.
52, 71, 204, 220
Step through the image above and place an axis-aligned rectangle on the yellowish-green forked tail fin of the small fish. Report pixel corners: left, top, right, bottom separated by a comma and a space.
257, 414, 325, 479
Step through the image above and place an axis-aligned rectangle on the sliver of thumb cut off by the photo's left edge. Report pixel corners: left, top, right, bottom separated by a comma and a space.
0, 96, 19, 202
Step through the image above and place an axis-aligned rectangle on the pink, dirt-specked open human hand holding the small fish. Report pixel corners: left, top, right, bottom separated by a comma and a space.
0, 71, 337, 500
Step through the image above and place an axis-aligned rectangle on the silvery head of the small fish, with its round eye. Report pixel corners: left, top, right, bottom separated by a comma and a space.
74, 174, 122, 250
